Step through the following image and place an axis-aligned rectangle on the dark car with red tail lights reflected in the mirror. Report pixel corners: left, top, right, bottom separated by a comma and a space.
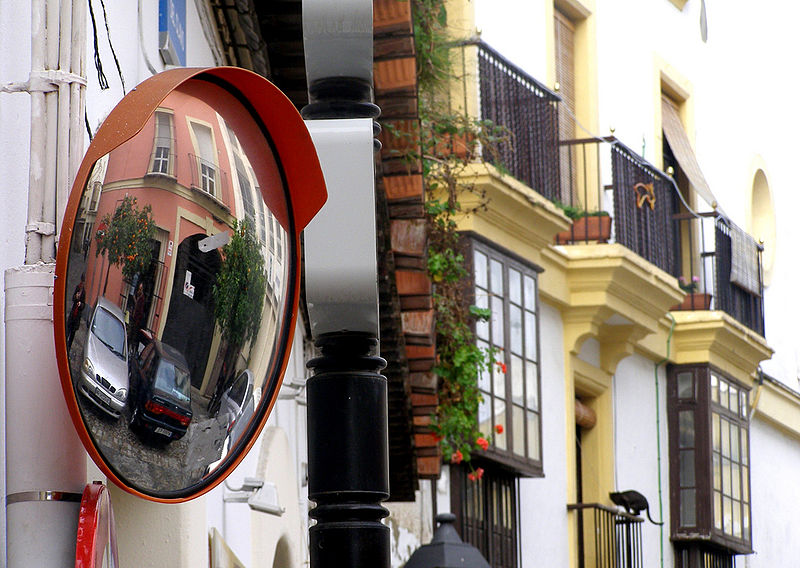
131, 339, 192, 441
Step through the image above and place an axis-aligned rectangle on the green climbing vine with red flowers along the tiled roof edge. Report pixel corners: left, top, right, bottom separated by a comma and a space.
409, 0, 508, 470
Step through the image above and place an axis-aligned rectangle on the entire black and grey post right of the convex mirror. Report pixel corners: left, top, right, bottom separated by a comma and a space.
302, 0, 390, 568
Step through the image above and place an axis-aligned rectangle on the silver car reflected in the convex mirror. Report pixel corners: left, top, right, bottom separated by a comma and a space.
78, 296, 128, 418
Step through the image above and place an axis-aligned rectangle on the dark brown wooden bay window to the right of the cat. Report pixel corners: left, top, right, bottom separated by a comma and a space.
668, 365, 751, 554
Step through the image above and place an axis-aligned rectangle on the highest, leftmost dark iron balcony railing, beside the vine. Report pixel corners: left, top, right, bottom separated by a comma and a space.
472, 42, 561, 200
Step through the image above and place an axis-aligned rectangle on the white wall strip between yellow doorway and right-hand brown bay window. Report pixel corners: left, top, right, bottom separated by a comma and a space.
613, 354, 673, 568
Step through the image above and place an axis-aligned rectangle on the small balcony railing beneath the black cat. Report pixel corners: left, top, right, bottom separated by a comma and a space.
567, 503, 644, 568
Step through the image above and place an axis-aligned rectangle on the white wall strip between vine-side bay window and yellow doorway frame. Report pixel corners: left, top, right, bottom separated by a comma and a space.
519, 302, 574, 568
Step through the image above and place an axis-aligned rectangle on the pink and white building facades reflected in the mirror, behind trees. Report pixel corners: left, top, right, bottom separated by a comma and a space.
73, 87, 286, 396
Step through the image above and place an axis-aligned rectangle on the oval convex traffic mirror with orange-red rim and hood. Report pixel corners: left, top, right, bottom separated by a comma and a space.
54, 68, 326, 502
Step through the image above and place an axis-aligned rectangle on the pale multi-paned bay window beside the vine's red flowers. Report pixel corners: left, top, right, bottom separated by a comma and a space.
472, 236, 542, 475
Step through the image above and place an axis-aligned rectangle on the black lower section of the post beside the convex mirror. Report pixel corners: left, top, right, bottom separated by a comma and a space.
306, 332, 390, 568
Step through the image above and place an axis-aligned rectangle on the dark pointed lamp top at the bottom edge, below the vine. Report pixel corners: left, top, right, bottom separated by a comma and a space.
405, 513, 491, 568
